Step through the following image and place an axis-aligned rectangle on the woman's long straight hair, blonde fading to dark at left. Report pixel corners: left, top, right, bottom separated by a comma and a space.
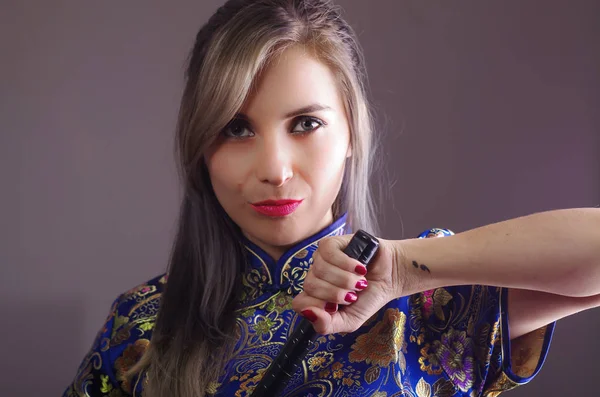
126, 0, 377, 397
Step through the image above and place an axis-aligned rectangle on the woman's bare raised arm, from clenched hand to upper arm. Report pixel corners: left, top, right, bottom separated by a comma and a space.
292, 208, 600, 335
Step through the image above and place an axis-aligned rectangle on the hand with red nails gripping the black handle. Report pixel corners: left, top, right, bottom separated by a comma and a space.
292, 235, 404, 334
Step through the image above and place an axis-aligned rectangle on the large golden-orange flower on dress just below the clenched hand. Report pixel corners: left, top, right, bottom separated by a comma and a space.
348, 309, 406, 368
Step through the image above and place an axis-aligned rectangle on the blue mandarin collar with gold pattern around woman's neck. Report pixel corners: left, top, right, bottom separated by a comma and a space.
242, 213, 350, 304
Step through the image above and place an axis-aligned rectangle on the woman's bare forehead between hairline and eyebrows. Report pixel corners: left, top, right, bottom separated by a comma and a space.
242, 46, 343, 116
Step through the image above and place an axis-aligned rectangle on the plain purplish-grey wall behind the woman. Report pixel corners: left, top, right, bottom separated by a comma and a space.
0, 0, 600, 397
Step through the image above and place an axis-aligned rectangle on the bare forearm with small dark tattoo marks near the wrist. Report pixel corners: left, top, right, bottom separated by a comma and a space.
396, 208, 600, 296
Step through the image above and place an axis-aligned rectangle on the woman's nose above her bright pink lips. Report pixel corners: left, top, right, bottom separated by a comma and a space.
256, 134, 294, 187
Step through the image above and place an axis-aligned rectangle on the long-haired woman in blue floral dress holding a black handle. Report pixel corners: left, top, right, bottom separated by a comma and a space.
65, 0, 600, 397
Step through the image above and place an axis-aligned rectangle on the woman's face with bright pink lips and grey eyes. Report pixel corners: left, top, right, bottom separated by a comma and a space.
207, 47, 350, 259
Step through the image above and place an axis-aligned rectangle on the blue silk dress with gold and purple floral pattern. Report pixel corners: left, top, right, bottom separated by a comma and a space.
64, 215, 554, 397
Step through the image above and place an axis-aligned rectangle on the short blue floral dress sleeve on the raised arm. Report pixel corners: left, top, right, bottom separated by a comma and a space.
411, 229, 555, 397
